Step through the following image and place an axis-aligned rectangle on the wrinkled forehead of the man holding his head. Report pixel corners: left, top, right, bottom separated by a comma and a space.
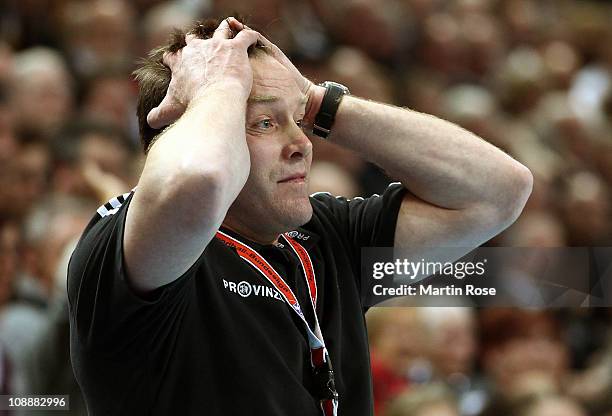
249, 54, 305, 104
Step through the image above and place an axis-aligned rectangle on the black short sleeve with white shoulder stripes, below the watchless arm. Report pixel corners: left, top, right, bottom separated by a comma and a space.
68, 192, 202, 353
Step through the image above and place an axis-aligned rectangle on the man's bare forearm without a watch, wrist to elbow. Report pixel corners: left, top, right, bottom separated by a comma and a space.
141, 87, 250, 213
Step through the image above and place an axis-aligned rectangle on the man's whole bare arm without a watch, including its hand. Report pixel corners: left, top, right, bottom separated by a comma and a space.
124, 19, 257, 292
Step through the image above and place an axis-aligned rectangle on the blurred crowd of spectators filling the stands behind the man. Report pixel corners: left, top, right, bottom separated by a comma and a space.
0, 0, 612, 416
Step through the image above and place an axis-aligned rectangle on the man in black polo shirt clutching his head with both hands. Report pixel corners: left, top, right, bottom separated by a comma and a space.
68, 18, 532, 416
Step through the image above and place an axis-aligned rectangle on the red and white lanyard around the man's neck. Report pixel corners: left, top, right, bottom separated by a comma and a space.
216, 231, 338, 416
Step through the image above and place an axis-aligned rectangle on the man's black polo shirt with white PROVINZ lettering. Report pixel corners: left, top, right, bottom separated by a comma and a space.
68, 184, 404, 416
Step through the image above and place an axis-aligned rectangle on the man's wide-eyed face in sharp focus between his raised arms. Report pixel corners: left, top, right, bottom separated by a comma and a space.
225, 55, 312, 239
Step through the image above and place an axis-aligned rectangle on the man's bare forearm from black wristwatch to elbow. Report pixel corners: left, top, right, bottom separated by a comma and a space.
320, 96, 531, 214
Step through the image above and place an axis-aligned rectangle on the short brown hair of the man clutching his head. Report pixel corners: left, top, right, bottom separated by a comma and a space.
132, 19, 268, 154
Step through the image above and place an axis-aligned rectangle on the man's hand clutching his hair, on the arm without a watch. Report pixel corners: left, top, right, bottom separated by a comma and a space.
147, 17, 259, 129
